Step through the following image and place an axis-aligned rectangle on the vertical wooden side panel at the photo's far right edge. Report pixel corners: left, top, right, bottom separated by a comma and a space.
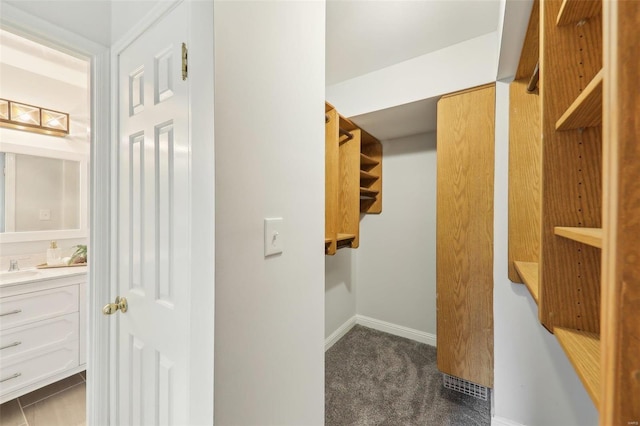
600, 1, 640, 426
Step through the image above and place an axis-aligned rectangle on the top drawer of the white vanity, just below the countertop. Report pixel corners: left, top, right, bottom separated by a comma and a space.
0, 285, 78, 330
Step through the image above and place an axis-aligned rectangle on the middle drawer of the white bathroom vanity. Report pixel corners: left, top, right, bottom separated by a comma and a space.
0, 312, 80, 365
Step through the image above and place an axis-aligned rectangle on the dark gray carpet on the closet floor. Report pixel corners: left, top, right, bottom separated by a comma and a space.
325, 325, 491, 426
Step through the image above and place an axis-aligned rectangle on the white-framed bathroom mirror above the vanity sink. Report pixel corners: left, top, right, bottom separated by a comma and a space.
0, 143, 89, 244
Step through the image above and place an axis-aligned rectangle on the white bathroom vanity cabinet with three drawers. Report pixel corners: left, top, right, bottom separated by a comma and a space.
0, 268, 87, 403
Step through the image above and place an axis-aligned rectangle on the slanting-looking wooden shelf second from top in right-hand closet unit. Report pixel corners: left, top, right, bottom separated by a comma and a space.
556, 70, 603, 130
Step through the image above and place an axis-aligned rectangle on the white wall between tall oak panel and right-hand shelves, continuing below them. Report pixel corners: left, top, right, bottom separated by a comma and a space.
493, 82, 598, 426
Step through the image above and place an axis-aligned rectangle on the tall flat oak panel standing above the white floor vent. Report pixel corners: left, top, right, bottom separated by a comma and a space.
436, 84, 495, 387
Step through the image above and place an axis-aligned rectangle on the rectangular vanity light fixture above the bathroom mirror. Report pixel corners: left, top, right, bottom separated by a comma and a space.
0, 98, 69, 137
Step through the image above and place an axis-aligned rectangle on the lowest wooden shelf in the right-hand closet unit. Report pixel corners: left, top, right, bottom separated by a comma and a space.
553, 327, 600, 407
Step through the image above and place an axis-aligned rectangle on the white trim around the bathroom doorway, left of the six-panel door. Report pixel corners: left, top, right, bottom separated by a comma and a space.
0, 4, 112, 424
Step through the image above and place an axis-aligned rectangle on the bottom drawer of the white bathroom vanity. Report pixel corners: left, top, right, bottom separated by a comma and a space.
0, 340, 78, 395
